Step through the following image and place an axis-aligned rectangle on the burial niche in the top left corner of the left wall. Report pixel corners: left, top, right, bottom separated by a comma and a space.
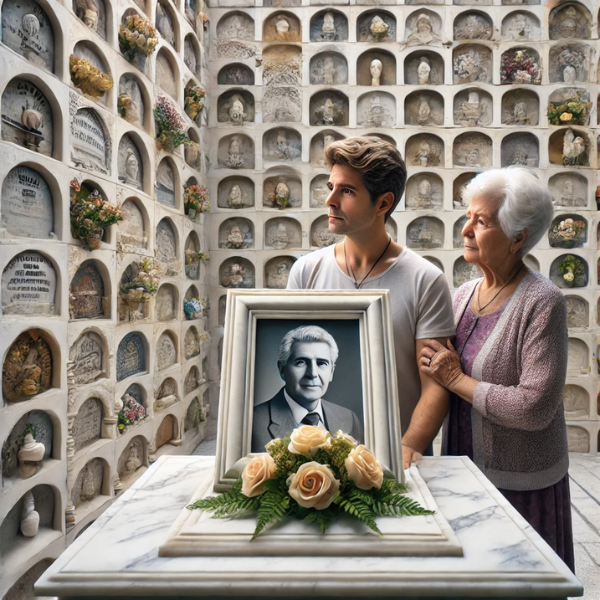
2, 0, 54, 72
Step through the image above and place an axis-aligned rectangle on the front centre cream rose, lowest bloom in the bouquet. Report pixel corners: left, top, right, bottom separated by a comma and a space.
287, 461, 340, 510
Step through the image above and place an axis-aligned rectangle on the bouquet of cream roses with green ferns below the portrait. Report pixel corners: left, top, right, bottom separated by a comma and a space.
188, 425, 432, 540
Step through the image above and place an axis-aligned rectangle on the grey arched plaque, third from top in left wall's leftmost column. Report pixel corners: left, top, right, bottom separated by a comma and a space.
0, 167, 54, 239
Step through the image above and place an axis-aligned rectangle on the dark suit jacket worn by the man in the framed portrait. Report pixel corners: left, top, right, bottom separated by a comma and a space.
251, 388, 363, 452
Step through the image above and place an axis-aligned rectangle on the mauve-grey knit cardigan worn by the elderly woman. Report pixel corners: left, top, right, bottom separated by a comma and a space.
442, 271, 569, 490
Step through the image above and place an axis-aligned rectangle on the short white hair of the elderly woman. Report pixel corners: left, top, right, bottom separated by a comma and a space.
463, 167, 554, 256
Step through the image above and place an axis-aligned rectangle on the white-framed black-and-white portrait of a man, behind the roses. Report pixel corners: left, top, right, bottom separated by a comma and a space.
214, 289, 404, 491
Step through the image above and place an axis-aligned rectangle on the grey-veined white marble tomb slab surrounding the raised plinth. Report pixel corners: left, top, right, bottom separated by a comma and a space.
35, 456, 583, 600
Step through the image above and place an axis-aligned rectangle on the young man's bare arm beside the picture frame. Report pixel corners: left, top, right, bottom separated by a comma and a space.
402, 338, 450, 469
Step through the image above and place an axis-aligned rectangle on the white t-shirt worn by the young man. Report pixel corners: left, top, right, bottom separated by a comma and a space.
287, 245, 454, 433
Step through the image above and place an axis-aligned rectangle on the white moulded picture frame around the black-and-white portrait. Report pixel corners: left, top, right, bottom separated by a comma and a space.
214, 289, 404, 492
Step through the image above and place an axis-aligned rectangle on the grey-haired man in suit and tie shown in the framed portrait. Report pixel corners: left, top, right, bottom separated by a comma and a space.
251, 325, 363, 452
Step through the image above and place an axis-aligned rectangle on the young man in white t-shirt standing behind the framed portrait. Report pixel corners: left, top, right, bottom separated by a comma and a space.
288, 137, 454, 468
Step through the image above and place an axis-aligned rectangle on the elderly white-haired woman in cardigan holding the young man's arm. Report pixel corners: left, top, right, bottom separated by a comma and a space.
419, 168, 574, 569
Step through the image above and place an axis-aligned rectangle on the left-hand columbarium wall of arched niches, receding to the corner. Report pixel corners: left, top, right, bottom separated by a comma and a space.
0, 0, 210, 598
